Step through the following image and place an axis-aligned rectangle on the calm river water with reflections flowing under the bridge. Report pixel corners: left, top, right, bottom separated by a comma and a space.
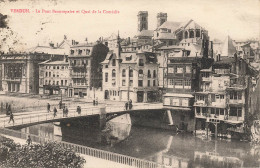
17, 115, 260, 168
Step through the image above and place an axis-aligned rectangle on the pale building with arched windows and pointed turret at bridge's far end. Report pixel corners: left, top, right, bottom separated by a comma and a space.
101, 34, 158, 102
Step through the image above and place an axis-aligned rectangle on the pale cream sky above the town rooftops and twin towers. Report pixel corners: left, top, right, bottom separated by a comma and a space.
0, 0, 260, 50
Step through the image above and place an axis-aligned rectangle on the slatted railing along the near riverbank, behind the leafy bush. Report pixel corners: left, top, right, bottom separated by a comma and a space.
0, 128, 168, 168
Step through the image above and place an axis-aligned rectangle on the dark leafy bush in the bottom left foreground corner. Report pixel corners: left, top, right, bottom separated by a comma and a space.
0, 139, 86, 168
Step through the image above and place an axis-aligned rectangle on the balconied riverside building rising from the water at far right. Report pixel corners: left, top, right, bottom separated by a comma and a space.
194, 36, 257, 136
